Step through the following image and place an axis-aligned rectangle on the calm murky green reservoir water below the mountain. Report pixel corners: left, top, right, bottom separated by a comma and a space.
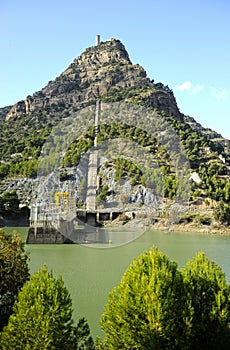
4, 228, 230, 337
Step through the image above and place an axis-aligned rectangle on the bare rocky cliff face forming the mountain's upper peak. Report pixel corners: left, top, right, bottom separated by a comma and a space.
6, 39, 181, 120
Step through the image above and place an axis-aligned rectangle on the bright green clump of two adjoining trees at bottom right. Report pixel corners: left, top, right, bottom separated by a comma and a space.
97, 248, 230, 350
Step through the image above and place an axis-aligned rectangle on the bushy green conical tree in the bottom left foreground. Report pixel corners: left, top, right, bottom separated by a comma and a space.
0, 266, 94, 350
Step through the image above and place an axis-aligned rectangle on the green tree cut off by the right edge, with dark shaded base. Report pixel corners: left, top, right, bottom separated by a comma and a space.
182, 253, 230, 350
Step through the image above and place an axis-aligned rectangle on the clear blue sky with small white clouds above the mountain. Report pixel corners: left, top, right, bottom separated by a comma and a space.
0, 0, 230, 139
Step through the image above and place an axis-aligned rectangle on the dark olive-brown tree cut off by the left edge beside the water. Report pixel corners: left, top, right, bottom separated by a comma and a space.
0, 229, 29, 330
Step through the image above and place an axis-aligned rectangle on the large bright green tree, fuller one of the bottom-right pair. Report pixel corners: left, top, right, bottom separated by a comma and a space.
99, 248, 188, 350
